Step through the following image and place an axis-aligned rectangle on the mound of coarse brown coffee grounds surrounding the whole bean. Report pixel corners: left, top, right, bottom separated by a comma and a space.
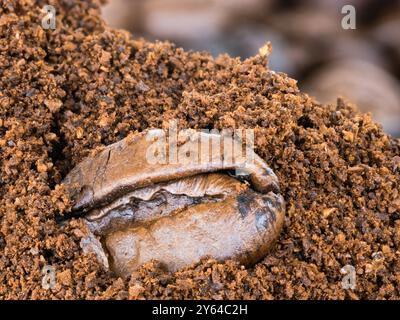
0, 0, 400, 299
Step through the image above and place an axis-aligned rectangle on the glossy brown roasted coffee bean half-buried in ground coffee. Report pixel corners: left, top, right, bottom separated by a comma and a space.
64, 132, 285, 277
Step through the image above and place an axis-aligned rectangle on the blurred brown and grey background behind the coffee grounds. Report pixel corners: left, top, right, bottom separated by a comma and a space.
103, 0, 400, 137
